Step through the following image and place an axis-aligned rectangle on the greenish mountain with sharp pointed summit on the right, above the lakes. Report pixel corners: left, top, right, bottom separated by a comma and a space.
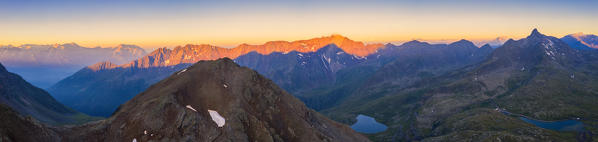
322, 29, 598, 141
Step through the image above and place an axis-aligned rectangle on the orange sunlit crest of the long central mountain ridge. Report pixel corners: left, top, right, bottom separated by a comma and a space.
96, 35, 384, 68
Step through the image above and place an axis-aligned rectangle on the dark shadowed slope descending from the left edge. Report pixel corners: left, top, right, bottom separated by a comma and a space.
0, 64, 93, 125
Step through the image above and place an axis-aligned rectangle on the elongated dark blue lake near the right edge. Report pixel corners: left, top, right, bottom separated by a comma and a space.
519, 117, 584, 132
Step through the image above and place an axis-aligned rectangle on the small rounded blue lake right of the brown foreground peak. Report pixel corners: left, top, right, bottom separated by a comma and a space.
351, 114, 388, 134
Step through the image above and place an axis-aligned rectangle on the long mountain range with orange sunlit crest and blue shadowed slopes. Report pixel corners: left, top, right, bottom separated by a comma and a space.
48, 35, 492, 116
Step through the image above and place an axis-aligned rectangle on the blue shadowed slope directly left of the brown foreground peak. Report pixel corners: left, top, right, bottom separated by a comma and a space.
48, 62, 191, 117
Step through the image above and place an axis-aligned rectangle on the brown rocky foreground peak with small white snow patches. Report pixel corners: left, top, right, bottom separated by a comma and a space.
61, 58, 369, 142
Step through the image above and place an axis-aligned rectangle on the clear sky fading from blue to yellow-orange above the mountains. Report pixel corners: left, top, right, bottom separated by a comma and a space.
0, 0, 598, 50
